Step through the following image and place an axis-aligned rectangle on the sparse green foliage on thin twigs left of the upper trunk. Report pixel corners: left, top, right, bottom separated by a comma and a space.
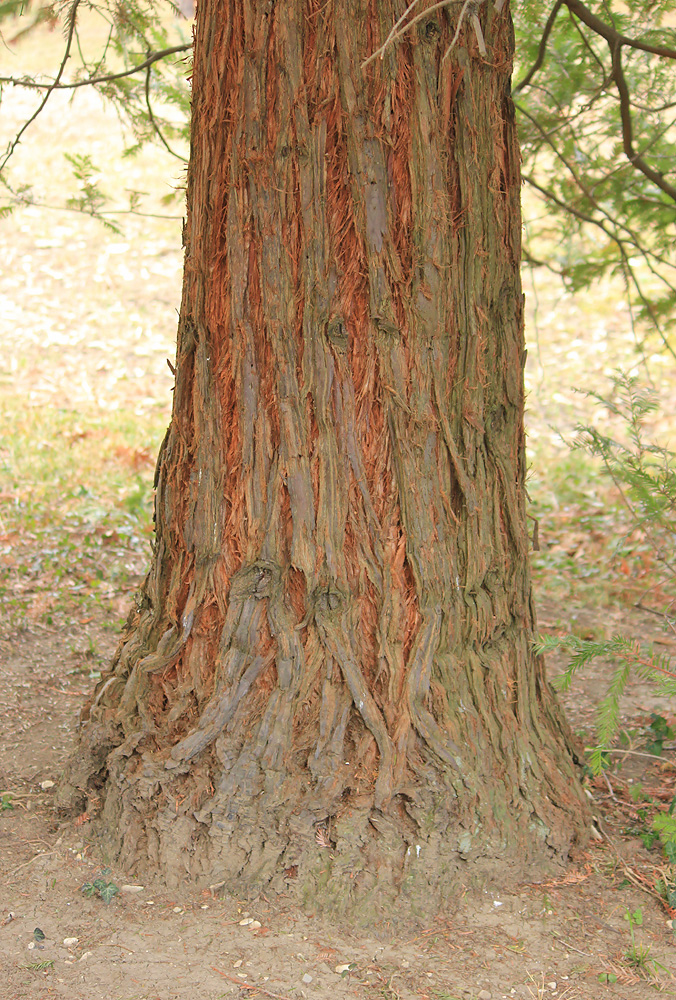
0, 0, 192, 219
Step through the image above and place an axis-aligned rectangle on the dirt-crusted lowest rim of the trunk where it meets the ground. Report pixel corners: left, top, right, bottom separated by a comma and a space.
58, 724, 589, 928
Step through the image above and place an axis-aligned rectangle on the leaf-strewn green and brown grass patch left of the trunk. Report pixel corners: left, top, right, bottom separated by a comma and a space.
0, 398, 165, 630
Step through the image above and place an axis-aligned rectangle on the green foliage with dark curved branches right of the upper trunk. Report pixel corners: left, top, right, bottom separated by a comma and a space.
514, 0, 676, 352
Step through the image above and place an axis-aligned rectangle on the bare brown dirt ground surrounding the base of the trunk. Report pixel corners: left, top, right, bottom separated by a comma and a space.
0, 604, 676, 1000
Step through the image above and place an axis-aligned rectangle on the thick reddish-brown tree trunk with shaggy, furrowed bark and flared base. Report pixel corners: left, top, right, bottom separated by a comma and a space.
64, 0, 587, 909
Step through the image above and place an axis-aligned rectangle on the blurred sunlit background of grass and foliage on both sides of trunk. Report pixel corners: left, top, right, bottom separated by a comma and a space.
0, 0, 676, 756
